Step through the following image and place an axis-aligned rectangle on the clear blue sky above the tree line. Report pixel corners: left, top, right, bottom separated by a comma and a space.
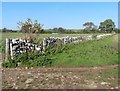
0, 2, 118, 29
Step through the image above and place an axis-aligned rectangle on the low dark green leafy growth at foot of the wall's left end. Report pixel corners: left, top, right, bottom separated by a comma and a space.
2, 52, 52, 68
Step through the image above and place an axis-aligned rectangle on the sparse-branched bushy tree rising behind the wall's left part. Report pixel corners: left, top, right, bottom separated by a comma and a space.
17, 18, 43, 33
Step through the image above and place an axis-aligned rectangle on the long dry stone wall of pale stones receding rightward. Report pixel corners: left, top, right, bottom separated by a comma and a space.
6, 34, 112, 59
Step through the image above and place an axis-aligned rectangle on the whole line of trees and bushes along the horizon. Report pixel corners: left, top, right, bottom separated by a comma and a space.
2, 18, 120, 34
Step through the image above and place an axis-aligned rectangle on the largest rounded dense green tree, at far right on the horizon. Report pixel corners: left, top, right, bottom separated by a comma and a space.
99, 19, 115, 32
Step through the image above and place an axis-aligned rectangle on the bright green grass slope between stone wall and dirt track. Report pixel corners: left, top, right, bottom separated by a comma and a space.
51, 36, 118, 67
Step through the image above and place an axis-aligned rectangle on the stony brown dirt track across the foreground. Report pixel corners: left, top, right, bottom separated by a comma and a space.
2, 65, 118, 89
